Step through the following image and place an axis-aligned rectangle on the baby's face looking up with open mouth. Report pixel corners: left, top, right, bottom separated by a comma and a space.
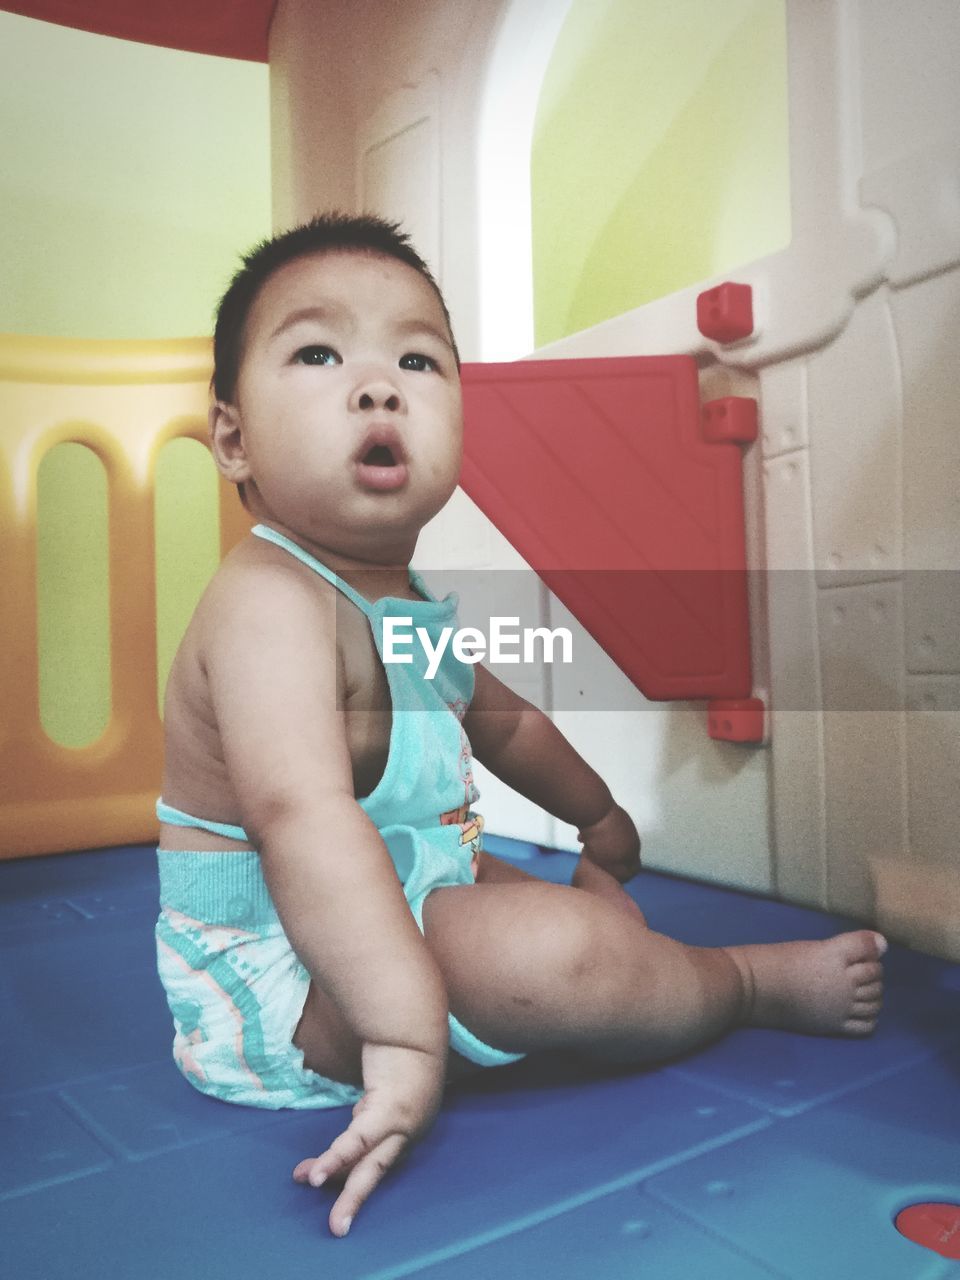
236, 251, 462, 554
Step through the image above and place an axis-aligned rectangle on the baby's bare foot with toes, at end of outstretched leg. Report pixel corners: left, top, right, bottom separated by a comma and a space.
726, 929, 887, 1036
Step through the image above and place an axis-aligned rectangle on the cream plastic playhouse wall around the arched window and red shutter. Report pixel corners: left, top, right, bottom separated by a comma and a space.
271, 0, 960, 957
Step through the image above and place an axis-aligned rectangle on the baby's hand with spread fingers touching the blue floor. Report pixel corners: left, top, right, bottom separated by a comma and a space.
293, 1044, 447, 1235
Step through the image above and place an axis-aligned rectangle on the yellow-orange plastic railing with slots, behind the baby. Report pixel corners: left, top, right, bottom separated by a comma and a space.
0, 335, 250, 858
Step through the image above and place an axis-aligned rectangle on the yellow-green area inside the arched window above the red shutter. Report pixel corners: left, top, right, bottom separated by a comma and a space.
530, 0, 790, 346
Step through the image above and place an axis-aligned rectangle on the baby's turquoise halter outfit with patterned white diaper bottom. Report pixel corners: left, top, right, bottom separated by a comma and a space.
156, 525, 522, 1108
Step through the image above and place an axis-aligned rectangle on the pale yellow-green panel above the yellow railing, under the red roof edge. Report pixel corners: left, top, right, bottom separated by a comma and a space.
0, 10, 270, 339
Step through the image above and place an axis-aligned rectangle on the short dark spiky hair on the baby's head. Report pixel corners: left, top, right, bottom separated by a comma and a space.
211, 212, 460, 403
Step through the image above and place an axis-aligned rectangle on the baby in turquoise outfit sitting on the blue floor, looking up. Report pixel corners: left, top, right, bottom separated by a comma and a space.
157, 215, 886, 1235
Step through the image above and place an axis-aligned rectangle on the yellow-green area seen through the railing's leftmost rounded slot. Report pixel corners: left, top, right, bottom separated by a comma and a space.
37, 443, 110, 748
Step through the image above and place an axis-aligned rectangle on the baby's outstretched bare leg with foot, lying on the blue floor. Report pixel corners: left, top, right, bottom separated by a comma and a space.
424, 881, 884, 1062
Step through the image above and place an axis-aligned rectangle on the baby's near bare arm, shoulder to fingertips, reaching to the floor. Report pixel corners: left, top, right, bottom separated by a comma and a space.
202, 566, 448, 1234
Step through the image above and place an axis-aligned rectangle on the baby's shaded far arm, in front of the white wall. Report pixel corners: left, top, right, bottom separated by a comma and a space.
465, 666, 640, 882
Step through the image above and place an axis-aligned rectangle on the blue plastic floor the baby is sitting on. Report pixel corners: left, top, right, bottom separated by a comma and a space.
0, 842, 960, 1280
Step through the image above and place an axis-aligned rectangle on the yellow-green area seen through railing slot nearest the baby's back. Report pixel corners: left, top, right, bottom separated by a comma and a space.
154, 439, 221, 717
